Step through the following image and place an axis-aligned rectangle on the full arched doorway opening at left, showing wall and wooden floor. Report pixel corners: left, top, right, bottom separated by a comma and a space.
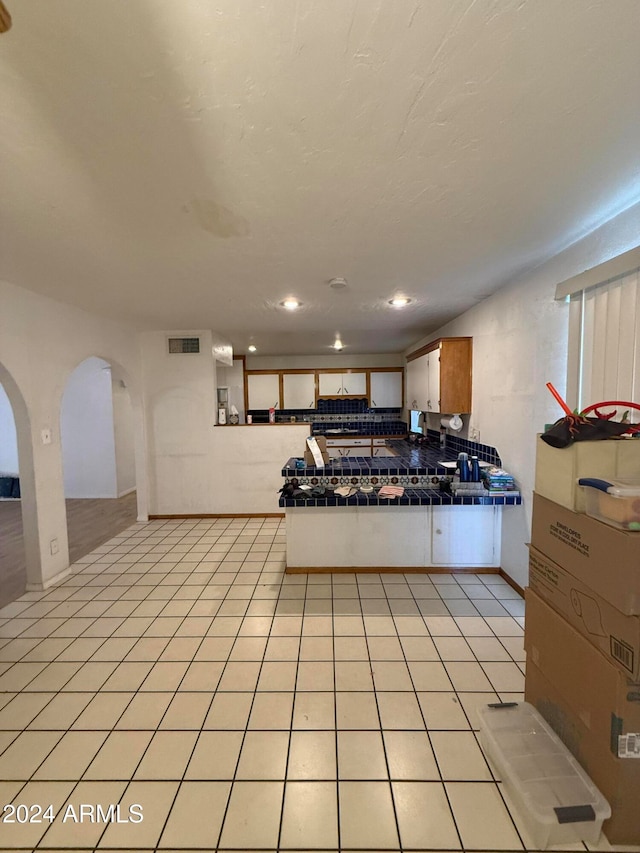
60, 356, 137, 563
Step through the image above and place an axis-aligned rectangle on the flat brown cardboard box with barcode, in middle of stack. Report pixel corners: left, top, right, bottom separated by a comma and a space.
529, 546, 640, 678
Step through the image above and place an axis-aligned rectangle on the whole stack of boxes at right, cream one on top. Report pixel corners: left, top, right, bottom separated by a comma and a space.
525, 439, 640, 844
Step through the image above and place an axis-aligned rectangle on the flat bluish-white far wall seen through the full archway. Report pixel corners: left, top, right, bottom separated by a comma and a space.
60, 357, 118, 498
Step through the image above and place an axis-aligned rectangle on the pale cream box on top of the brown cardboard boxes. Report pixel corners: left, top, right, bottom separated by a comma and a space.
534, 436, 640, 512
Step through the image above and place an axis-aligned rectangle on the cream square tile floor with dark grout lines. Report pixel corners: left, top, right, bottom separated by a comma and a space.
0, 518, 640, 851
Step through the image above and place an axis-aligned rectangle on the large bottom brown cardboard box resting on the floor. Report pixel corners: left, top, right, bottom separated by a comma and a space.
525, 590, 640, 844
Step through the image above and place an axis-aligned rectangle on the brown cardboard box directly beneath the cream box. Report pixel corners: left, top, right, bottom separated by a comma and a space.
531, 494, 640, 616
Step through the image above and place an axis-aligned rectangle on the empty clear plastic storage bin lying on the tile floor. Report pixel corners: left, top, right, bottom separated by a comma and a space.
480, 702, 611, 850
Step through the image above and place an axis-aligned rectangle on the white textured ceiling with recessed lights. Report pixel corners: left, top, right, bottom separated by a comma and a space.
0, 0, 640, 355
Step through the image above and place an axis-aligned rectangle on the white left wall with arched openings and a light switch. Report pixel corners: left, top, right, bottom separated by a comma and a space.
0, 282, 146, 587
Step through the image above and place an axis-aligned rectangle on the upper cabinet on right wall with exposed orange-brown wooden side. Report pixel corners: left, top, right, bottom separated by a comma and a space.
407, 338, 472, 414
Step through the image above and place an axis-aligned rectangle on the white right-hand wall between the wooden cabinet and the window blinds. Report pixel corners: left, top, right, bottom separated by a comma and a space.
407, 205, 640, 586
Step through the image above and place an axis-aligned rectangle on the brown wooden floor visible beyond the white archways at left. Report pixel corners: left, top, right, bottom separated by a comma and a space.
0, 492, 137, 607
